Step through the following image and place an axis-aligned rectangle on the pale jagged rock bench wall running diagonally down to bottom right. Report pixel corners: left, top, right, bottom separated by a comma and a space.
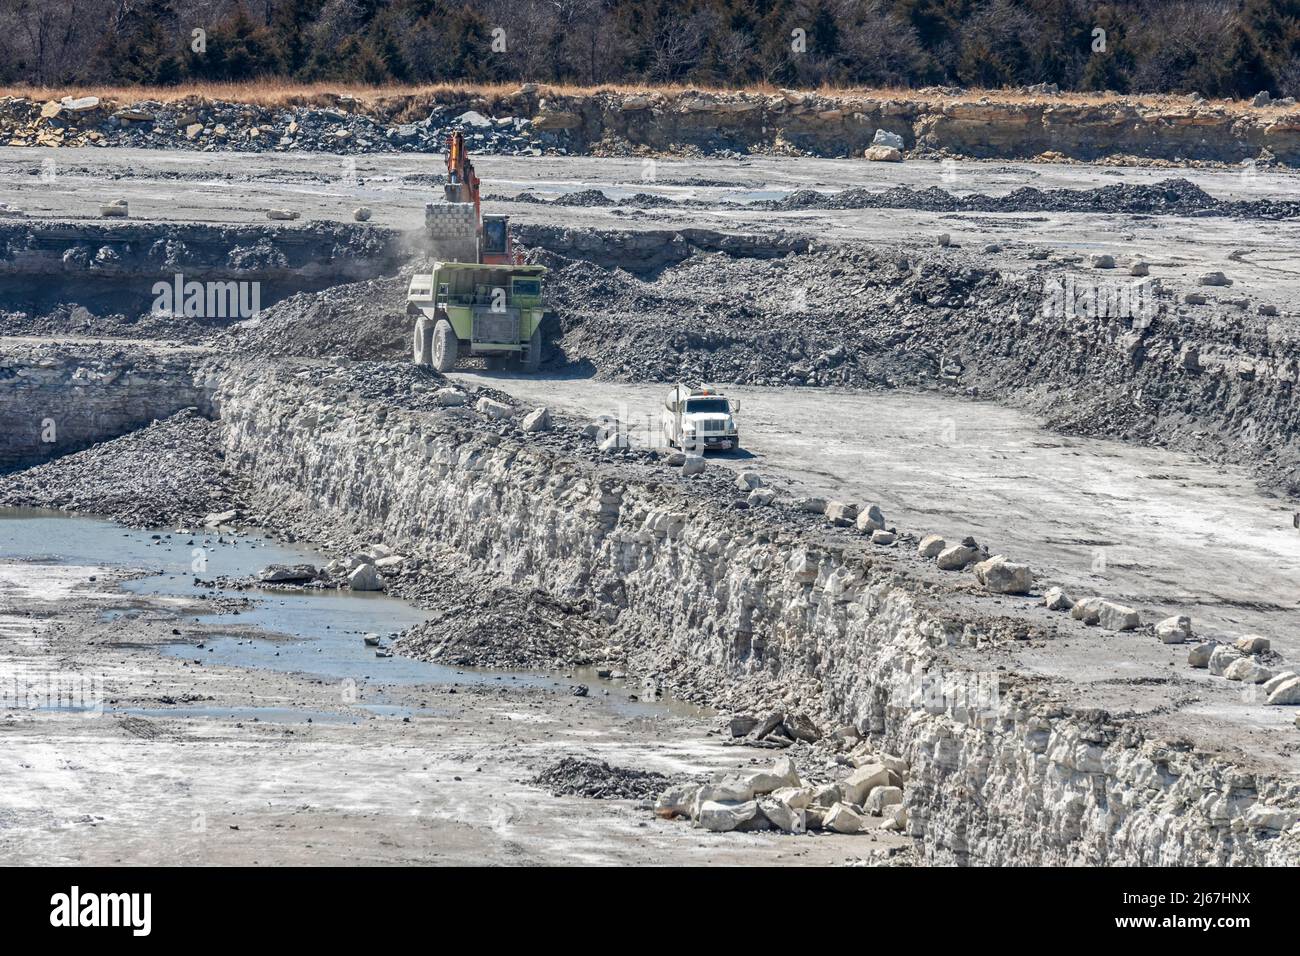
215, 367, 1300, 865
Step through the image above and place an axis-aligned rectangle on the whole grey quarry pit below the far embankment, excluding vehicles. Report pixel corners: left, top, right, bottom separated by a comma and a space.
0, 127, 1300, 866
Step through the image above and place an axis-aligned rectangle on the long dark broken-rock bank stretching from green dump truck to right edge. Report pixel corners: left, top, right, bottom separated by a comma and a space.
546, 237, 1300, 490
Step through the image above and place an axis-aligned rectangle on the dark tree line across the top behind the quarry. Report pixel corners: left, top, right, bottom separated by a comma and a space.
0, 0, 1300, 96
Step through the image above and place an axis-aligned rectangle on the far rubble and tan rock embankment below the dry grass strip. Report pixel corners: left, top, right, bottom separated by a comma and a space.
10, 85, 1300, 164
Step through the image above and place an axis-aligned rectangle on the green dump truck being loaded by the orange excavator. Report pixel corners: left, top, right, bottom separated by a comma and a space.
407, 263, 546, 372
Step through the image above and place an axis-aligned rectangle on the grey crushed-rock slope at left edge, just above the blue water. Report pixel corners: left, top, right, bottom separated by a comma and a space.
0, 411, 244, 528
